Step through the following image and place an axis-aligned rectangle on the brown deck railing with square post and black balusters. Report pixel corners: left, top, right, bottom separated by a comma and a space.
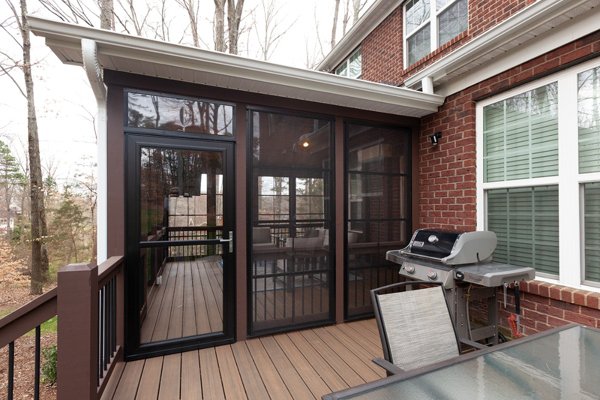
0, 257, 124, 400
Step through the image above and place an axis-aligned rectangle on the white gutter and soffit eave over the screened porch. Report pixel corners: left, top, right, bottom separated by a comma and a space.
29, 17, 444, 117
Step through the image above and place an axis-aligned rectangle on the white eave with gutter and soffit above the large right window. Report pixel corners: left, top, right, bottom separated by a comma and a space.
405, 0, 600, 96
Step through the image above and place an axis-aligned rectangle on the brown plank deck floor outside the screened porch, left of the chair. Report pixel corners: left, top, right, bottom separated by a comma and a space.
102, 319, 385, 400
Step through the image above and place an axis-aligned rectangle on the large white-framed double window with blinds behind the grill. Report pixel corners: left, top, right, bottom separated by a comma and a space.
477, 60, 600, 287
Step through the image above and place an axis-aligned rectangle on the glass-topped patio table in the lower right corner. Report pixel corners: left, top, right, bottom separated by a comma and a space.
323, 324, 600, 400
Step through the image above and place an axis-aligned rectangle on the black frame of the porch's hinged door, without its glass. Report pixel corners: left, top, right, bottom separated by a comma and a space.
125, 132, 236, 361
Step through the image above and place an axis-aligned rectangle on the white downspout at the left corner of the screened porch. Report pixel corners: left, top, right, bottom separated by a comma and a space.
81, 39, 108, 264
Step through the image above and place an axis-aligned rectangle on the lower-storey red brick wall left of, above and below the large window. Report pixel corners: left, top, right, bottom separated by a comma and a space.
418, 31, 600, 334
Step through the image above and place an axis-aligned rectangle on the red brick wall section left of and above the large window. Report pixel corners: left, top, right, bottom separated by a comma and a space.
418, 31, 600, 230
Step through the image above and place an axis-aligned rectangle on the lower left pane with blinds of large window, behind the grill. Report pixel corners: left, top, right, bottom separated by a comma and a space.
487, 185, 559, 276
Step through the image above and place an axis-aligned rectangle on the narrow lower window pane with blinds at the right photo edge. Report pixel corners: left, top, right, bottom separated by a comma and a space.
583, 182, 600, 282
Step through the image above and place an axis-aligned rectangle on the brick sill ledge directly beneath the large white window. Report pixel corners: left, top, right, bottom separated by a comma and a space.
520, 281, 600, 310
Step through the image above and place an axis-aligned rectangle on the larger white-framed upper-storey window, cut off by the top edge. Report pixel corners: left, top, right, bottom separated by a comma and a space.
404, 0, 469, 66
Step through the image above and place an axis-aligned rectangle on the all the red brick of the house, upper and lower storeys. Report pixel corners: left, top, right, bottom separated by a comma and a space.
354, 0, 600, 340
